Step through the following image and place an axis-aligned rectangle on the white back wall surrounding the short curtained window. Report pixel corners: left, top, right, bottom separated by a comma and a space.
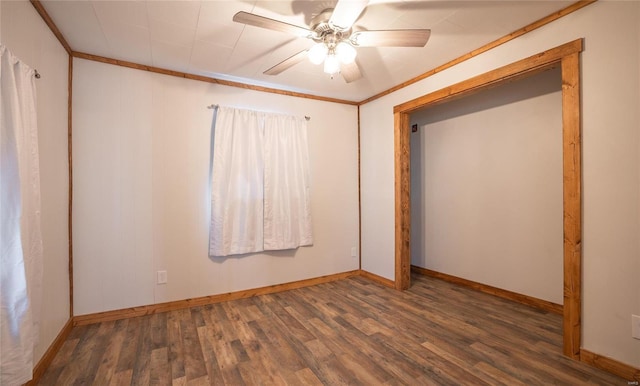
73, 59, 358, 315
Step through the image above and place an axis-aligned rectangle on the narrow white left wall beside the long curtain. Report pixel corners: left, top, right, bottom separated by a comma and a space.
0, 1, 69, 363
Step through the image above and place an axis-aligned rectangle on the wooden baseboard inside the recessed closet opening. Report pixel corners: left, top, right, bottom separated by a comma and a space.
411, 265, 563, 315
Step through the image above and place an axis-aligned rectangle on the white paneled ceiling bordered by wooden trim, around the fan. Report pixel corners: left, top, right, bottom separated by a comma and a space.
41, 0, 573, 101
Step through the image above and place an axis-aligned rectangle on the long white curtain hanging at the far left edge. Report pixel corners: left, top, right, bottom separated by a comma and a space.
0, 45, 42, 385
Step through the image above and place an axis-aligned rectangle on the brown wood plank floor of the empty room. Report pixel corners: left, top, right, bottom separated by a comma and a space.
39, 275, 627, 386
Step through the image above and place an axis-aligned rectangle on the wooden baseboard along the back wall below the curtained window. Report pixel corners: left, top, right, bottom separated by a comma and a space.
73, 270, 360, 326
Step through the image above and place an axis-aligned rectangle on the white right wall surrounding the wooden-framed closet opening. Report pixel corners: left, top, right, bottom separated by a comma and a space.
360, 1, 640, 367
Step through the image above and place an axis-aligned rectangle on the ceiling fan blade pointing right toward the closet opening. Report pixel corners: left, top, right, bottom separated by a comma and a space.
349, 29, 431, 47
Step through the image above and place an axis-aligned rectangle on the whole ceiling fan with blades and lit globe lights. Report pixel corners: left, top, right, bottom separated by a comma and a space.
233, 0, 431, 83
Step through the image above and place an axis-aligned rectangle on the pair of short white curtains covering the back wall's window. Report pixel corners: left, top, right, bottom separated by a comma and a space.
209, 107, 313, 256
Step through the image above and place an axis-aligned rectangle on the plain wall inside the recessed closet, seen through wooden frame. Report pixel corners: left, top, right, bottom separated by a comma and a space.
411, 69, 563, 304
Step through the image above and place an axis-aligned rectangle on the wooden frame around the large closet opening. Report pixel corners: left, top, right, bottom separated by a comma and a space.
393, 39, 583, 359
